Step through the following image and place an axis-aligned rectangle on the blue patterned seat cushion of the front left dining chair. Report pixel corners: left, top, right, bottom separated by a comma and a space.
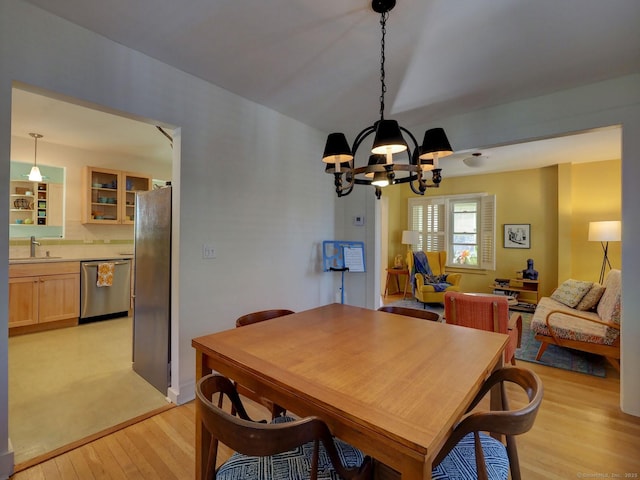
216, 417, 364, 480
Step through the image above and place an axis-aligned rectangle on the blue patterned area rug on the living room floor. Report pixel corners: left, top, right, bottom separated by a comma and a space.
382, 300, 606, 377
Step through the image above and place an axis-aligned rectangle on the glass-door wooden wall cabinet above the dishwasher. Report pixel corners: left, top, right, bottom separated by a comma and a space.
82, 167, 151, 225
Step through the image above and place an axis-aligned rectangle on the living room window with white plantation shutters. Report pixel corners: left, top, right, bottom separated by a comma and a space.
409, 194, 495, 270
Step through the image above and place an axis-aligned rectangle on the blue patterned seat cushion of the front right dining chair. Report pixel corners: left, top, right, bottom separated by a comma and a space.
431, 433, 509, 480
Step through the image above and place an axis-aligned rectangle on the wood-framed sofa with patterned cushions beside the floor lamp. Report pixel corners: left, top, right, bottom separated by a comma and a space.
531, 269, 622, 371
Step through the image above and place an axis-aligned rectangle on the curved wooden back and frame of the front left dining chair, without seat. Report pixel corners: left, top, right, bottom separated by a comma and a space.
196, 373, 372, 480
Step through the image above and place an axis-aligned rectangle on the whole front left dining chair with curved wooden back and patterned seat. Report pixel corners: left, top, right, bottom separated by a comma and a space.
196, 373, 373, 480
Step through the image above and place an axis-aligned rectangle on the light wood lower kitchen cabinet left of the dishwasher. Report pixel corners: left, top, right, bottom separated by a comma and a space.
9, 261, 80, 335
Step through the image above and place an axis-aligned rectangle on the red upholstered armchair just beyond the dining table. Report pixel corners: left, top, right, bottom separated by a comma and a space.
444, 292, 522, 365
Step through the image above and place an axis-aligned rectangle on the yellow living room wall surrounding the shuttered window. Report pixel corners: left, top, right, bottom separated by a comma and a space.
383, 160, 621, 295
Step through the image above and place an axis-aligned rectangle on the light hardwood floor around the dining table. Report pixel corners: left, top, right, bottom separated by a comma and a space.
12, 298, 640, 480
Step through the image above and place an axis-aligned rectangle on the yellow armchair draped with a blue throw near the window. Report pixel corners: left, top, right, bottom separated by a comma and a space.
407, 251, 462, 305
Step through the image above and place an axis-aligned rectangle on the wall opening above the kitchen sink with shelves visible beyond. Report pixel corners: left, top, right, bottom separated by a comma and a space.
9, 162, 64, 238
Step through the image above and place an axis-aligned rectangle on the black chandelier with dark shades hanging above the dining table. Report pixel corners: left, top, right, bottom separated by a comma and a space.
322, 0, 453, 199
